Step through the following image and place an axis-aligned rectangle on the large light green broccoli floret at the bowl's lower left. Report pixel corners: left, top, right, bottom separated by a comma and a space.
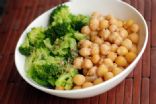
26, 48, 65, 87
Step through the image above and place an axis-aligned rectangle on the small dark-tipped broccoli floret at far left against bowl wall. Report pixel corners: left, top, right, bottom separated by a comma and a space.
19, 37, 33, 56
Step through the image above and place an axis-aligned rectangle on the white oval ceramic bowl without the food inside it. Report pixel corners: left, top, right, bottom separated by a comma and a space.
15, 0, 148, 98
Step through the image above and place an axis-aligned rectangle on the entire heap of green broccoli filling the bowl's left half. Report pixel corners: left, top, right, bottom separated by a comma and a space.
19, 5, 89, 90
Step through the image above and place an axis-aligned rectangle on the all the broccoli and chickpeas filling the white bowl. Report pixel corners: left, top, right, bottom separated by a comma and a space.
19, 5, 139, 90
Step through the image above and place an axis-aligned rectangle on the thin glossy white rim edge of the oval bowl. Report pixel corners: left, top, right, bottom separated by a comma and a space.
14, 0, 149, 94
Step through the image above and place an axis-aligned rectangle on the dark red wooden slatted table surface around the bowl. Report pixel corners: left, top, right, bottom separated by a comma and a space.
0, 0, 156, 104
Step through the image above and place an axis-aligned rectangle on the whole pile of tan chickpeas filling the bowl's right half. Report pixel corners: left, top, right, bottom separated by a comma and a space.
73, 12, 139, 89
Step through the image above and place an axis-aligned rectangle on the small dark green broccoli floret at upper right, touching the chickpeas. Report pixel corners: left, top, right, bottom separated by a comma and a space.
71, 15, 89, 31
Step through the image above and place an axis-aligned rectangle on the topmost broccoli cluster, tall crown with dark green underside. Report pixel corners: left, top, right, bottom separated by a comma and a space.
45, 5, 89, 43
